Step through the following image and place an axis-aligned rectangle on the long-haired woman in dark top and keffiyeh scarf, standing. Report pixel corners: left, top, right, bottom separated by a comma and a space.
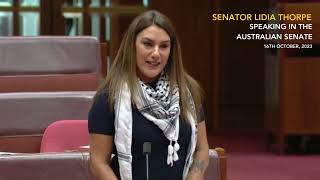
89, 11, 208, 180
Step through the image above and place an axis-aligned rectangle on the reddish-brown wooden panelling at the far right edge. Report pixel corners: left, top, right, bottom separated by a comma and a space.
266, 3, 320, 154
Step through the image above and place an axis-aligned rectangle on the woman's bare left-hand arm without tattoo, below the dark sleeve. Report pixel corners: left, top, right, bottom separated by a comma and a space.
90, 134, 117, 180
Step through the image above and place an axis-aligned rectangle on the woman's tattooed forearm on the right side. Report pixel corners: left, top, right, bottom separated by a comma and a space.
187, 121, 209, 180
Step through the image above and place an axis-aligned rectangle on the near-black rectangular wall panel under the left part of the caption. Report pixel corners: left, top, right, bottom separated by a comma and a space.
216, 0, 268, 133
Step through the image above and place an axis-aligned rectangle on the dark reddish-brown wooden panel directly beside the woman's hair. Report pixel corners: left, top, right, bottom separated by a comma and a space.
150, 0, 215, 130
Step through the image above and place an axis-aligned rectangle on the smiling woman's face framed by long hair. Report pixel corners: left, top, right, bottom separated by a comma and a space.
136, 25, 171, 83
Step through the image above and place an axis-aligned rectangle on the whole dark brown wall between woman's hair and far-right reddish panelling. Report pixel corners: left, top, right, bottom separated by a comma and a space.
151, 0, 268, 132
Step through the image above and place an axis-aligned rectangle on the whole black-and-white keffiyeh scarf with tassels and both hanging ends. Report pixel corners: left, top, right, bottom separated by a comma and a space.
114, 75, 196, 180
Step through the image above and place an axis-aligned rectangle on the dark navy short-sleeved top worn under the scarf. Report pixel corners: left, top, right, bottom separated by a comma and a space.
88, 93, 202, 180
